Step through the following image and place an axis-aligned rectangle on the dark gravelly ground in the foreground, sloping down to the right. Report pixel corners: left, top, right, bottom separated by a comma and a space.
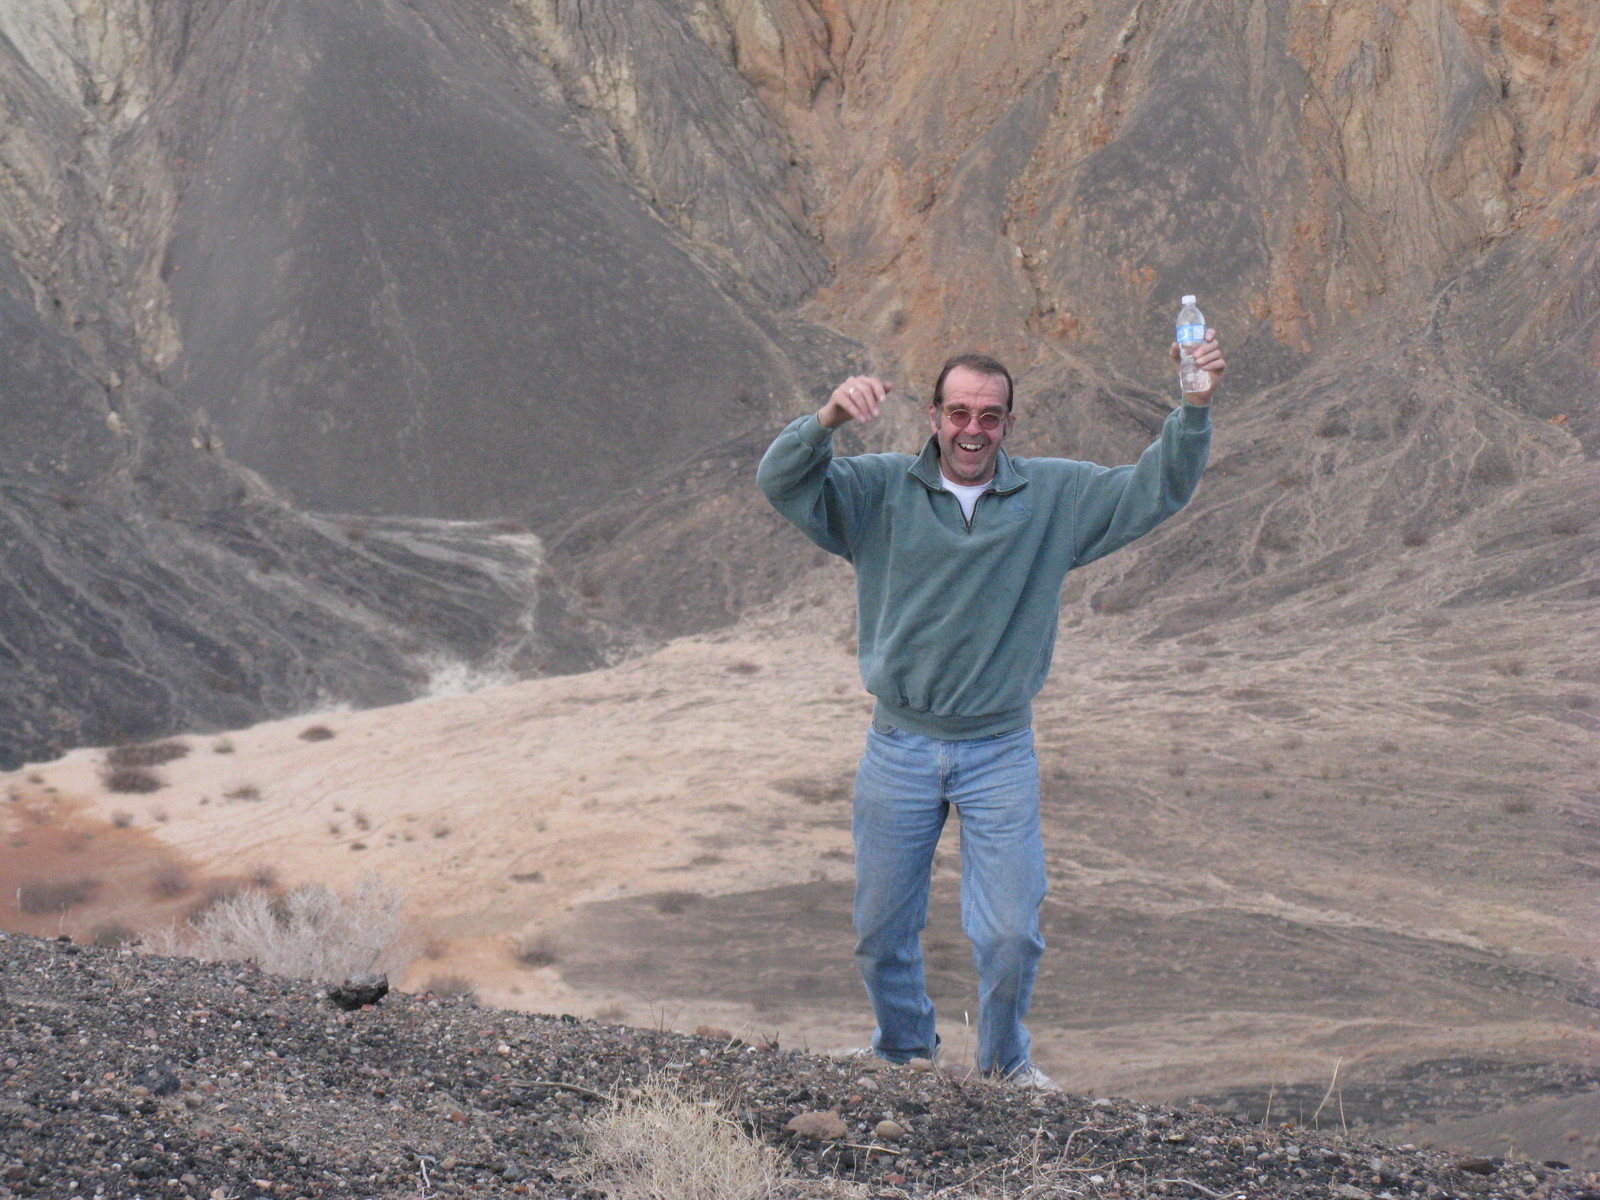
0, 934, 1600, 1200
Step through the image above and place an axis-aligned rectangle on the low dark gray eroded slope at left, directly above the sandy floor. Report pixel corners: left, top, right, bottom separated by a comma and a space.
0, 243, 597, 770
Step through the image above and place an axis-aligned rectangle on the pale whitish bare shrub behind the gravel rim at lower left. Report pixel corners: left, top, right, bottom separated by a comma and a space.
176, 875, 411, 982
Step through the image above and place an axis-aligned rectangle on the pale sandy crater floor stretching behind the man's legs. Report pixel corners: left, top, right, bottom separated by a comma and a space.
5, 553, 1600, 1157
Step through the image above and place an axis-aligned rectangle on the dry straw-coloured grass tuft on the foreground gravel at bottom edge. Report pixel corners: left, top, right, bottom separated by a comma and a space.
578, 1082, 782, 1200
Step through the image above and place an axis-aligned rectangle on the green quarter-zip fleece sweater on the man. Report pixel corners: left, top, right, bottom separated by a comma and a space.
757, 405, 1211, 739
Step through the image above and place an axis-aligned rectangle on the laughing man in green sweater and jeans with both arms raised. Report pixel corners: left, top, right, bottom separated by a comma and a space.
757, 330, 1226, 1090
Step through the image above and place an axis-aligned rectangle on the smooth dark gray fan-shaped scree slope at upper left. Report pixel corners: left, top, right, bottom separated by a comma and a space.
150, 0, 838, 517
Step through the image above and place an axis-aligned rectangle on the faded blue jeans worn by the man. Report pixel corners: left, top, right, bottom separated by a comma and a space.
851, 722, 1045, 1075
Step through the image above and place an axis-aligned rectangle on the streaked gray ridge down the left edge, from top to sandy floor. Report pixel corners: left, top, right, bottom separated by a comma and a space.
0, 6, 624, 765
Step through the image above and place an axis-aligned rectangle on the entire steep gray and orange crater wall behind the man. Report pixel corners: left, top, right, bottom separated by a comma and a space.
0, 0, 1600, 762
